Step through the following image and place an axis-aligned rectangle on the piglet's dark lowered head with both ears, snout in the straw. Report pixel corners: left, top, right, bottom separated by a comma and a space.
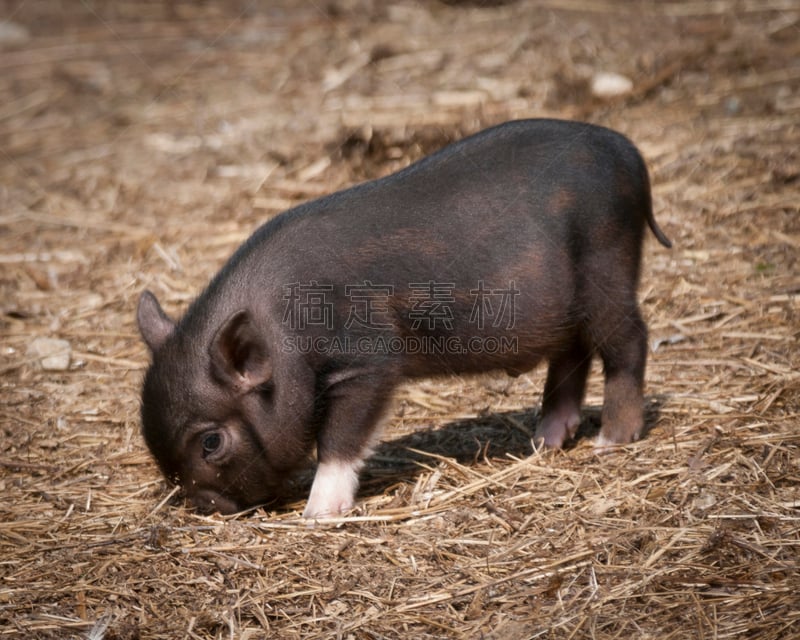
137, 291, 314, 513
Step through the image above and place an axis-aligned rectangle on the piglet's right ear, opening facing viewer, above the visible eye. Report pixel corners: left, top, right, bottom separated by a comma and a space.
209, 311, 272, 393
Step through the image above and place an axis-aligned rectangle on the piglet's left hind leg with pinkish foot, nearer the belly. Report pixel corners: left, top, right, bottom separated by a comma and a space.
534, 335, 592, 448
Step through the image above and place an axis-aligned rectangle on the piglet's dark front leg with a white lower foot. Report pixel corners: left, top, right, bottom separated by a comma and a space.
303, 377, 390, 519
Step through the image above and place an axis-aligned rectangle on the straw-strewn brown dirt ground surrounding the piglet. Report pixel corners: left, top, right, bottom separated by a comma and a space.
0, 0, 800, 640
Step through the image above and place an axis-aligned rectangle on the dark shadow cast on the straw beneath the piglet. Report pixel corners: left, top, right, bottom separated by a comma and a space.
273, 396, 666, 509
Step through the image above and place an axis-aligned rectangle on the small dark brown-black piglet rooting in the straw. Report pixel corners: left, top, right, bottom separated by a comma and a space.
137, 120, 670, 518
